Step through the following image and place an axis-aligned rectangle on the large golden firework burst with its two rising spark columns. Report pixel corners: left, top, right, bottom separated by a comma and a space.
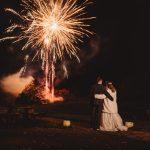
0, 0, 95, 101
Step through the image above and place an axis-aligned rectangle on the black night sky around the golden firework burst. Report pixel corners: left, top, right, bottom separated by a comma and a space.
0, 0, 150, 103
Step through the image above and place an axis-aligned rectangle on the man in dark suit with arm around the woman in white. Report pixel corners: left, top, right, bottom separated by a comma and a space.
91, 76, 113, 130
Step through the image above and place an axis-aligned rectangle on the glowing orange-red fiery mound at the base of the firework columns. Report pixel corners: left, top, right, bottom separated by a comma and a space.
16, 80, 69, 104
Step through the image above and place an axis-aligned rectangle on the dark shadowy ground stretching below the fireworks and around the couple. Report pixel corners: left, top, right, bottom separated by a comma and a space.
0, 98, 150, 150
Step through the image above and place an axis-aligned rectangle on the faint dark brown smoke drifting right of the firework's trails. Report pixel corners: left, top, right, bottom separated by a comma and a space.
55, 35, 102, 86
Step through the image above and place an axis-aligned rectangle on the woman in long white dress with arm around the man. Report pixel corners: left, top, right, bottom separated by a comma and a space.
95, 82, 128, 131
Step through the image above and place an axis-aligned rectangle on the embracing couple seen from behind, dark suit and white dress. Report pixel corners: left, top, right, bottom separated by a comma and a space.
91, 76, 128, 131
